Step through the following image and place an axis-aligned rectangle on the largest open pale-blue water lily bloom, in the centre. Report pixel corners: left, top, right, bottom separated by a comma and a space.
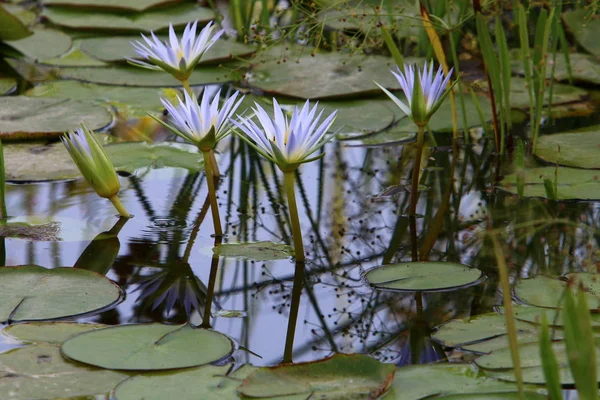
232, 99, 337, 172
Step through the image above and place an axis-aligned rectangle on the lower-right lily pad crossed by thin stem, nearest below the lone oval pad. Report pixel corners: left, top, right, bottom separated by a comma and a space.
433, 313, 537, 348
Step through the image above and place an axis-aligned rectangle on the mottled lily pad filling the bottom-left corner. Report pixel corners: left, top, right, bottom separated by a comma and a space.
0, 344, 127, 400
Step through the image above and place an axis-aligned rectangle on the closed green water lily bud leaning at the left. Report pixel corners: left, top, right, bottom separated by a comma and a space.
61, 124, 131, 218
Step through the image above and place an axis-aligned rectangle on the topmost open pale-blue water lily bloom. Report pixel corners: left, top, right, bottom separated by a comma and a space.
127, 21, 225, 82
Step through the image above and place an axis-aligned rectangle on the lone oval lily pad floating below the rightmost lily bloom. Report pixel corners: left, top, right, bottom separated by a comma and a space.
364, 261, 485, 292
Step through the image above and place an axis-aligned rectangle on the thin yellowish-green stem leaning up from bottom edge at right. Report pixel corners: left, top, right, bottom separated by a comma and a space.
490, 233, 525, 400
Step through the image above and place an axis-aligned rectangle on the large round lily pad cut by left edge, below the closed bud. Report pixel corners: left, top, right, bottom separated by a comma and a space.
0, 265, 121, 322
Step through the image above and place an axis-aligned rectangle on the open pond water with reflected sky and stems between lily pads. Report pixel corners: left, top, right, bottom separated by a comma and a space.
0, 92, 600, 365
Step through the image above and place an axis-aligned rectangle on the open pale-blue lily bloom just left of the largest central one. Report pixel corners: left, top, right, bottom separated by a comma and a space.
153, 90, 244, 152
